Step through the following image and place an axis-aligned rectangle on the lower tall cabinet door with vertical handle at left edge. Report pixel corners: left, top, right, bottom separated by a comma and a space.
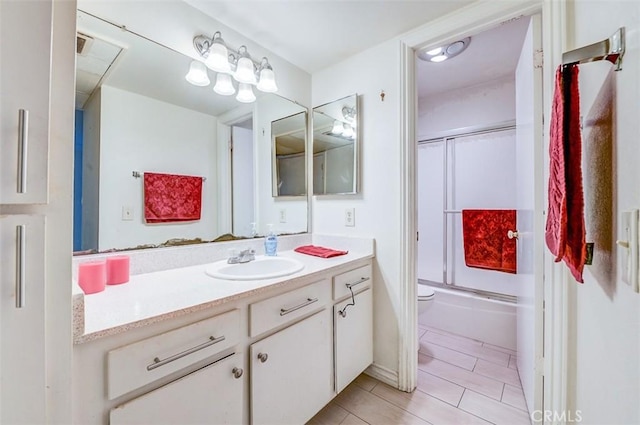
0, 215, 46, 424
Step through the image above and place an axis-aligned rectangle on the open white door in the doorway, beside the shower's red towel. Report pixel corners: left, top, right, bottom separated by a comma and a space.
513, 16, 544, 413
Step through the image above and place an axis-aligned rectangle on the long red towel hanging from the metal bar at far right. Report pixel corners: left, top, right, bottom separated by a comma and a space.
545, 65, 587, 283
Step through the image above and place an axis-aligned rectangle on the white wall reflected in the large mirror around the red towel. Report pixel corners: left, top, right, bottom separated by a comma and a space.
98, 86, 218, 251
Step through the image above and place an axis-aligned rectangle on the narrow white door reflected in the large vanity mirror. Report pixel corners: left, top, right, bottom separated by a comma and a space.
231, 126, 256, 236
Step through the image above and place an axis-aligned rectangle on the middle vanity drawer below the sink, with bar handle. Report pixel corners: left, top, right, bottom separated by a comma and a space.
249, 280, 331, 337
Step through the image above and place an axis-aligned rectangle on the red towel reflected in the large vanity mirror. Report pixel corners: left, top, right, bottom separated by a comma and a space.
144, 173, 202, 223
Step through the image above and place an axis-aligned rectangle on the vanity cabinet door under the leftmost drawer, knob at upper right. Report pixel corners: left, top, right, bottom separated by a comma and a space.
109, 354, 245, 425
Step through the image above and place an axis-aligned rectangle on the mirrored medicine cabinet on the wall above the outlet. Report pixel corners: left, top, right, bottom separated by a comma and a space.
313, 94, 360, 195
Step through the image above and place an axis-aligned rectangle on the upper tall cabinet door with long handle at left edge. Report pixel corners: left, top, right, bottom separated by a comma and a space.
0, 1, 53, 204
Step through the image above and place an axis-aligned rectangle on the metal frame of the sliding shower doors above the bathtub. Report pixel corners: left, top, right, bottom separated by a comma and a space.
418, 120, 517, 304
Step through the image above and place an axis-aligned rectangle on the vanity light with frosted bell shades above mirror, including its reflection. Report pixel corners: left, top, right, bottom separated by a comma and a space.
186, 31, 278, 103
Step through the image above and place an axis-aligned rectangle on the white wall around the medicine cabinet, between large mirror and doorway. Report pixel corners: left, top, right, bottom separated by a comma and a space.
312, 41, 402, 372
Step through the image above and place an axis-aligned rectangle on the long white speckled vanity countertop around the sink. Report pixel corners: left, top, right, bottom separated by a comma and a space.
73, 236, 374, 344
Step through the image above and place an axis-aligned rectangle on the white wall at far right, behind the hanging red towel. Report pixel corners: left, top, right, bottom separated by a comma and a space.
567, 0, 640, 424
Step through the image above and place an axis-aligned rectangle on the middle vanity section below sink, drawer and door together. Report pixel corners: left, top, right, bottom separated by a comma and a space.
249, 280, 333, 425
